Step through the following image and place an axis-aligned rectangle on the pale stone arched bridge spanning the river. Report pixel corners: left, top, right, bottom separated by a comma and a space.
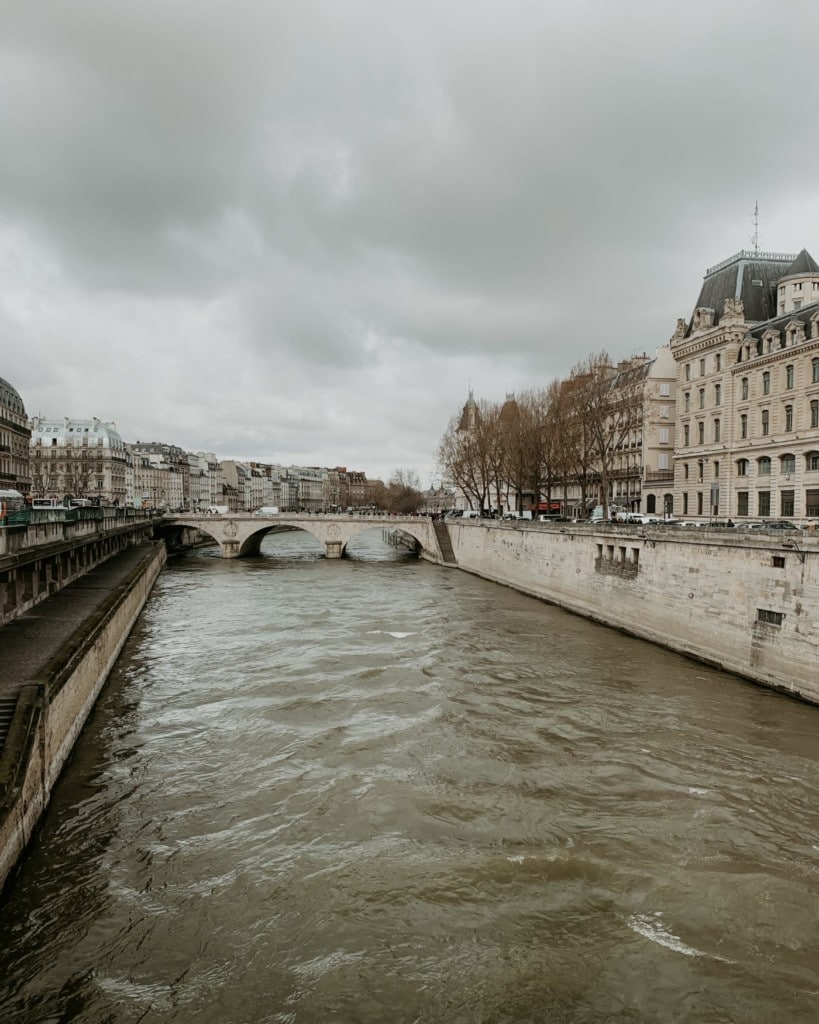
159, 512, 446, 562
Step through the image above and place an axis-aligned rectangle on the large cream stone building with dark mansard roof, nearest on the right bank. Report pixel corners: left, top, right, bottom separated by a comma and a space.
671, 250, 819, 520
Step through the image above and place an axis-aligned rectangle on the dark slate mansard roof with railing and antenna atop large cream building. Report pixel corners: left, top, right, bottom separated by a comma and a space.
687, 251, 801, 334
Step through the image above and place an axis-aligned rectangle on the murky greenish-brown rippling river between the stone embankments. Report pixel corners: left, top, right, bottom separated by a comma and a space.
0, 532, 819, 1024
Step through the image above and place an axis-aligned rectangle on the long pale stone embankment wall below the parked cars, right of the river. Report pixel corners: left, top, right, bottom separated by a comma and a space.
449, 522, 819, 703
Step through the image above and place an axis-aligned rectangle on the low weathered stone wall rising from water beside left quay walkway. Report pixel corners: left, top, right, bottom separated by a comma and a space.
0, 544, 166, 888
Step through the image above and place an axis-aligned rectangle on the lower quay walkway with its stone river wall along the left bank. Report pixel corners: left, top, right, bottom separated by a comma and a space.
0, 543, 167, 889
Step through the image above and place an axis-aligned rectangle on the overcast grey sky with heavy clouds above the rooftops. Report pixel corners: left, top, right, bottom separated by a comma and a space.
0, 0, 819, 485
